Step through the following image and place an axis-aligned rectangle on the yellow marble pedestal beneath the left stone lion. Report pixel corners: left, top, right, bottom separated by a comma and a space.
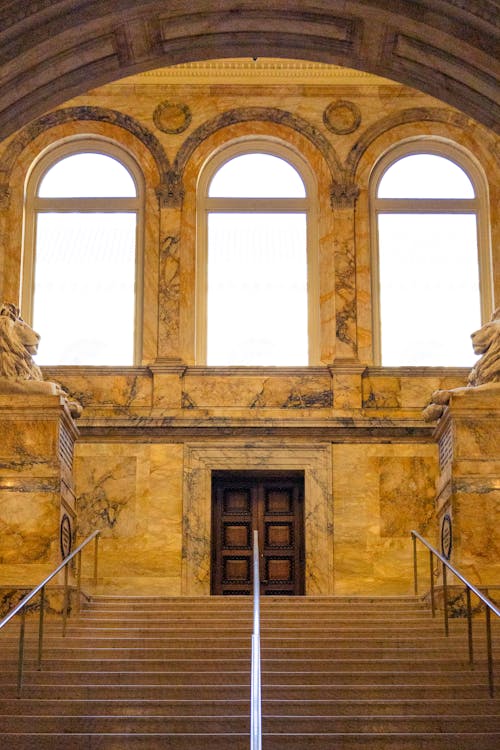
0, 393, 78, 588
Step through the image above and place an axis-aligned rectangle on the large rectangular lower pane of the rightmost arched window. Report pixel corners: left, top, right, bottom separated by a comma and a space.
379, 214, 481, 367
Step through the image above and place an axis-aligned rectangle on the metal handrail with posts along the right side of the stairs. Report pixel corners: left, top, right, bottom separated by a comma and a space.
411, 531, 500, 698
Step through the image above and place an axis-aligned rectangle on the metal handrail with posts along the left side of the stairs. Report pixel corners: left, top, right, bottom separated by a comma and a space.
0, 531, 101, 698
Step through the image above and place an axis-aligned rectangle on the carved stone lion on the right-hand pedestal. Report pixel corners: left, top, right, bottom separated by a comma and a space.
423, 307, 500, 422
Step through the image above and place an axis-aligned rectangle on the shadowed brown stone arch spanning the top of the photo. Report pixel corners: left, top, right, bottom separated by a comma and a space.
0, 0, 500, 138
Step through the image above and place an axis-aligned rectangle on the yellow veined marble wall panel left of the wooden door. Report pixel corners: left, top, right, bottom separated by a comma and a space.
75, 443, 182, 595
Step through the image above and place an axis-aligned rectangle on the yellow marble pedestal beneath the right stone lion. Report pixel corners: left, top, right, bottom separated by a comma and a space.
435, 383, 500, 586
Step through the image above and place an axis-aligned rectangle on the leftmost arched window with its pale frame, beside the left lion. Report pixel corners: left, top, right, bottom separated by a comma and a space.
22, 139, 142, 365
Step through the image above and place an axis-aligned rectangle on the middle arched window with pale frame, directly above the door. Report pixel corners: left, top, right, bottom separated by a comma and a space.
197, 141, 316, 366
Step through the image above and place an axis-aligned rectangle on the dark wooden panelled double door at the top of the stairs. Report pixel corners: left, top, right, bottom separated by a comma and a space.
212, 471, 304, 595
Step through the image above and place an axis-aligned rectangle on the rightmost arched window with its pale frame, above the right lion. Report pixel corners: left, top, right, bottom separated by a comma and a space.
372, 142, 491, 366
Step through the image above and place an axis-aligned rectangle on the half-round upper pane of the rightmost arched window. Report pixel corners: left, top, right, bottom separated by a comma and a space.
378, 154, 474, 198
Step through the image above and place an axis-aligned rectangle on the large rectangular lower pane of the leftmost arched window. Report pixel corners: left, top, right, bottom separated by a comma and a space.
33, 213, 136, 365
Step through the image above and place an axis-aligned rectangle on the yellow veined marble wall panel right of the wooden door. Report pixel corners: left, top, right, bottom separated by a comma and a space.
332, 444, 438, 595
